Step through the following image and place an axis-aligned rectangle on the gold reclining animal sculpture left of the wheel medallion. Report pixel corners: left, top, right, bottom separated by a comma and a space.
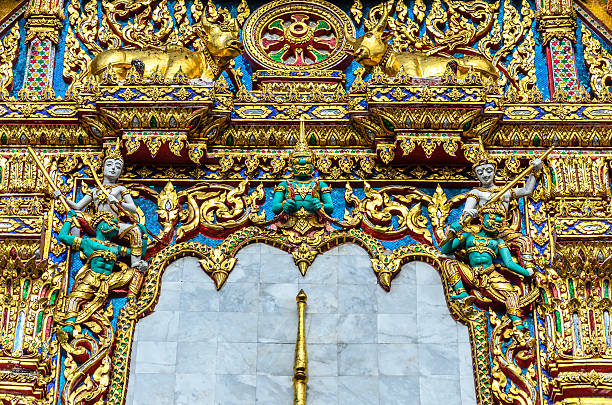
89, 13, 243, 82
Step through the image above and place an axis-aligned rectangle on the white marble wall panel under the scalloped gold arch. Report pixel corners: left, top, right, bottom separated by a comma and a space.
127, 244, 476, 405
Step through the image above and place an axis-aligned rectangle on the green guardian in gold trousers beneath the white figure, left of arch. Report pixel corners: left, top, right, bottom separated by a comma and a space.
58, 210, 147, 334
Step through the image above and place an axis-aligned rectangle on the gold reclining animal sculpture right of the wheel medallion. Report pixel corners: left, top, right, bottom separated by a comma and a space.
353, 6, 499, 80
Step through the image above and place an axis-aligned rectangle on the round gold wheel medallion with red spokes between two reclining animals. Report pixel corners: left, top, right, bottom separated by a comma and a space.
243, 0, 355, 71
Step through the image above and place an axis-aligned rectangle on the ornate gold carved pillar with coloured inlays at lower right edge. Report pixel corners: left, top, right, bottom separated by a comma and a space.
537, 241, 612, 403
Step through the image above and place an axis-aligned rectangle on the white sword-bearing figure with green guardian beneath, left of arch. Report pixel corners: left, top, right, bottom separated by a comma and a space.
28, 147, 147, 334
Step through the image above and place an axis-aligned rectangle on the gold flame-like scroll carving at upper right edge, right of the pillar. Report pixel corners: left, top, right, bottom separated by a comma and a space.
582, 28, 612, 102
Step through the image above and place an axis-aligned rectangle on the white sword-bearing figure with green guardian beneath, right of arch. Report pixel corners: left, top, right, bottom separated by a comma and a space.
440, 144, 552, 330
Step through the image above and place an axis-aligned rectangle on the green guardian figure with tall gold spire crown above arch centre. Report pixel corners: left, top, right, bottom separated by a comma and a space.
272, 117, 334, 235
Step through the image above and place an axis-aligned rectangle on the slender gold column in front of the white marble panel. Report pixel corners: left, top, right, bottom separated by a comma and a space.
293, 290, 308, 405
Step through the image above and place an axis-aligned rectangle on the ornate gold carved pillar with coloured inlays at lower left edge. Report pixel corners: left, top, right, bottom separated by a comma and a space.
0, 252, 62, 404
